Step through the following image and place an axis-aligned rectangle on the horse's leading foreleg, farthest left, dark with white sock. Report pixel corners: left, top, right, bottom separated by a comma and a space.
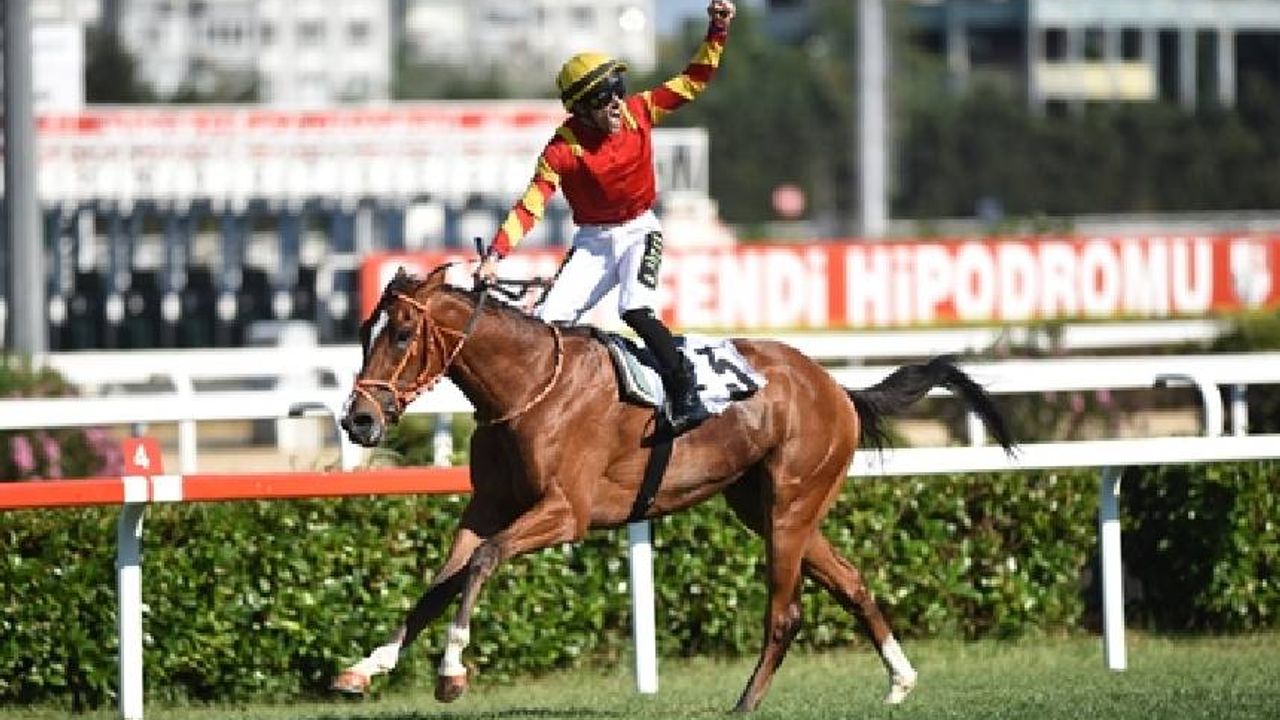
332, 527, 484, 694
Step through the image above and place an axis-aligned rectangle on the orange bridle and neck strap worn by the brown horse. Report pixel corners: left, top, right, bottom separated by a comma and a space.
352, 288, 564, 425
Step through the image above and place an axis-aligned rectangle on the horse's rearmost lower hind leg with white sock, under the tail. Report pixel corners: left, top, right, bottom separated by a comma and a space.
804, 532, 918, 705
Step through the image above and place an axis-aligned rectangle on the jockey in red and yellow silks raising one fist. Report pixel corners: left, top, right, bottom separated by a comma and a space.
479, 0, 736, 434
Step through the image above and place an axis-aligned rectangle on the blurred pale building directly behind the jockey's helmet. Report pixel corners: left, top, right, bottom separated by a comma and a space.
403, 0, 657, 81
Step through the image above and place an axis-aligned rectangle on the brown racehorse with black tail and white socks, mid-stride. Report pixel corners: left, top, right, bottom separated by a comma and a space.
334, 262, 1012, 711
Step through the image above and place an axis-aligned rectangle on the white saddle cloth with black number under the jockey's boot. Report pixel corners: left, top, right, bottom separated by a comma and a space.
600, 332, 765, 415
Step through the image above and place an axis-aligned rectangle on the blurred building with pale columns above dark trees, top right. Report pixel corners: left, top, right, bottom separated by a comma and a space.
767, 0, 1280, 109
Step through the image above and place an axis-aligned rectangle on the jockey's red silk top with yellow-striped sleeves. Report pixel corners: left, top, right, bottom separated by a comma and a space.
490, 24, 728, 256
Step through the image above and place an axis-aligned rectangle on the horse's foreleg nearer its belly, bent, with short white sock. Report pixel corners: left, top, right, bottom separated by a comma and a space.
435, 493, 585, 702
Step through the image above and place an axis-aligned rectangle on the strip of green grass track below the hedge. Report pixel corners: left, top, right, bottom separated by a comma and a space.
12, 633, 1280, 720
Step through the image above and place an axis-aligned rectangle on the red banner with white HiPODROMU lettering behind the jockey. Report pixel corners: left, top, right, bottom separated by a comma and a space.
361, 233, 1280, 331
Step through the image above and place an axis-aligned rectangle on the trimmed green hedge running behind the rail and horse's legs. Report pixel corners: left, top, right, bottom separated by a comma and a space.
0, 464, 1280, 707
